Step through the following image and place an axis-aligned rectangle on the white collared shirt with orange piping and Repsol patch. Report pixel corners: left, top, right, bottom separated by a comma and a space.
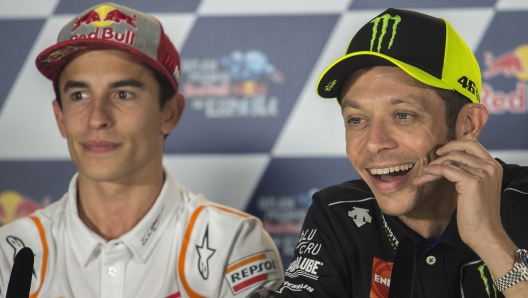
0, 171, 283, 298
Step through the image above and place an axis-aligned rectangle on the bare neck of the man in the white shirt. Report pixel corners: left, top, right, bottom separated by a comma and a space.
77, 169, 164, 240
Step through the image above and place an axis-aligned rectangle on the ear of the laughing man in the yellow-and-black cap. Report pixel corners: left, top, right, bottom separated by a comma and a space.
456, 103, 488, 140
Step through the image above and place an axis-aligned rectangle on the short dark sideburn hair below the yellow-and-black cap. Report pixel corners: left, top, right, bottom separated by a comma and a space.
433, 88, 471, 141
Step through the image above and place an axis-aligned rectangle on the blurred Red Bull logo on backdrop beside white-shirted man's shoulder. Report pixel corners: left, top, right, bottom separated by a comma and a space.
0, 190, 49, 225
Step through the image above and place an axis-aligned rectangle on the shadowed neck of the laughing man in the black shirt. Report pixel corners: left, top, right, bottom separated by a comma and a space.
398, 182, 458, 238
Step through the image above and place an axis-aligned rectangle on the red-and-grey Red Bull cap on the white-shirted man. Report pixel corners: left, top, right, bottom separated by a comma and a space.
36, 3, 180, 91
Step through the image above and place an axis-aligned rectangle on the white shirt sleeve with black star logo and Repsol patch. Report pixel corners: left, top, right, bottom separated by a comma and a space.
179, 198, 283, 297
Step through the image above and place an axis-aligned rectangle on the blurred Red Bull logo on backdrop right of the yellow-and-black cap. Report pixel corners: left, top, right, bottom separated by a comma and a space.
480, 44, 528, 114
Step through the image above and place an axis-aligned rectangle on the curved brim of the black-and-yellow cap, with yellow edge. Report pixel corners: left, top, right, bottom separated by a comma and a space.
317, 51, 455, 98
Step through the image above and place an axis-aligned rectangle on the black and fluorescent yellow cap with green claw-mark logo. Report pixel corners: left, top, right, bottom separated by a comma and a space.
317, 8, 482, 103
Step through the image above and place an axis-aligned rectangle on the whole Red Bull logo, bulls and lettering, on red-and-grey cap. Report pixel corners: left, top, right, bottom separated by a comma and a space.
70, 5, 137, 45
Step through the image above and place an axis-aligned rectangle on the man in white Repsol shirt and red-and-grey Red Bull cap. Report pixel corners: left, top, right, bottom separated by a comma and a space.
0, 3, 283, 298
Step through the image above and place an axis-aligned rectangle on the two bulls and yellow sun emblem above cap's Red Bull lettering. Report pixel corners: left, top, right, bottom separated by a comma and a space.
72, 5, 136, 32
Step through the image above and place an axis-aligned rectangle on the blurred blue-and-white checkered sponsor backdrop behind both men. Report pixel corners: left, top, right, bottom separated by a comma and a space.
0, 0, 528, 264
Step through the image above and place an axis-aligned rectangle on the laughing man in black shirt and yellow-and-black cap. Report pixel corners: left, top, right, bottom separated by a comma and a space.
277, 9, 528, 298
